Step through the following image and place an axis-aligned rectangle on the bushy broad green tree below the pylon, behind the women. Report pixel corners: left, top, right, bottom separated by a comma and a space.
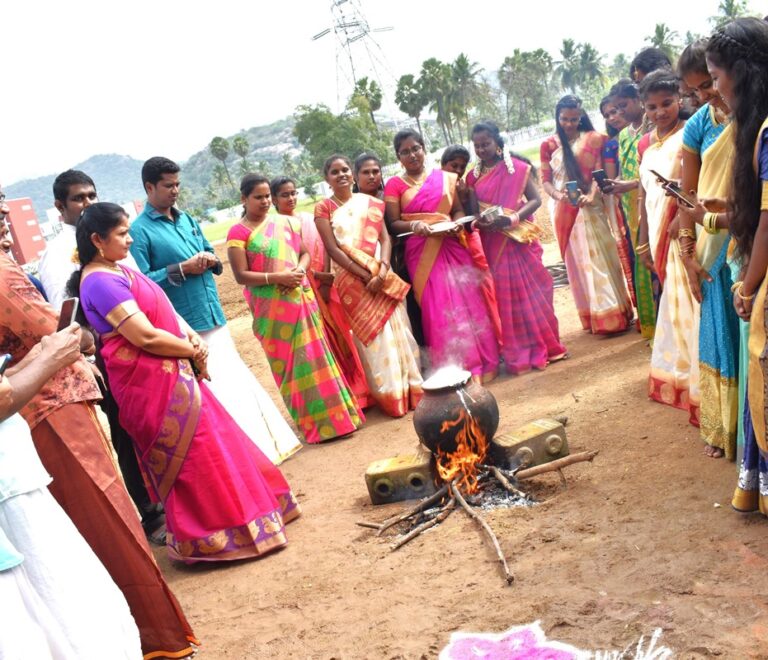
293, 105, 390, 172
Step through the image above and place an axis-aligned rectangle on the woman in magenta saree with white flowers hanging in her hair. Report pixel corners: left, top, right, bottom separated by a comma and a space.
467, 122, 567, 374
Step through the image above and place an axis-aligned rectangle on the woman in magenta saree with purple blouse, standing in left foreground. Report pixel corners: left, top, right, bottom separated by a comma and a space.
77, 204, 299, 563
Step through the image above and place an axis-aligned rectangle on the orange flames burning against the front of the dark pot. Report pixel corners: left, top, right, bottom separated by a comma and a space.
436, 410, 488, 495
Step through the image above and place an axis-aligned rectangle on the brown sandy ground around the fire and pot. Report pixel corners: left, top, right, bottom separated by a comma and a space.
156, 213, 768, 659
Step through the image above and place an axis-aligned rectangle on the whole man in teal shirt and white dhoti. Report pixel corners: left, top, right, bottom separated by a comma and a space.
130, 157, 301, 463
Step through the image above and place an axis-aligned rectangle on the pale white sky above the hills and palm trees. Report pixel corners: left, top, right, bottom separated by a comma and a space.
0, 0, 728, 184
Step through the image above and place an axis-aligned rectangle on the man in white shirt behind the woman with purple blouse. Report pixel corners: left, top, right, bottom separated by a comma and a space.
38, 170, 138, 311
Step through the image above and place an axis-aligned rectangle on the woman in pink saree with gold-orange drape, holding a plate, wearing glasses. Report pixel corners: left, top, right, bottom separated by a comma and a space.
384, 129, 501, 382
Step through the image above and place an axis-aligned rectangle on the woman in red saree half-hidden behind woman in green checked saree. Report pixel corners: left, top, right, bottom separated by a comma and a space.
269, 176, 373, 408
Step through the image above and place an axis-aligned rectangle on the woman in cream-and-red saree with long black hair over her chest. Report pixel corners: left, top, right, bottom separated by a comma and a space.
541, 95, 634, 334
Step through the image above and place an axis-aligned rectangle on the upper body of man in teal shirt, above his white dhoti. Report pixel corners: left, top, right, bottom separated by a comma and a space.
130, 156, 226, 332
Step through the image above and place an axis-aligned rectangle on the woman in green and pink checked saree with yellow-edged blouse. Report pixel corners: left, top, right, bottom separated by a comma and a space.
227, 174, 365, 443
